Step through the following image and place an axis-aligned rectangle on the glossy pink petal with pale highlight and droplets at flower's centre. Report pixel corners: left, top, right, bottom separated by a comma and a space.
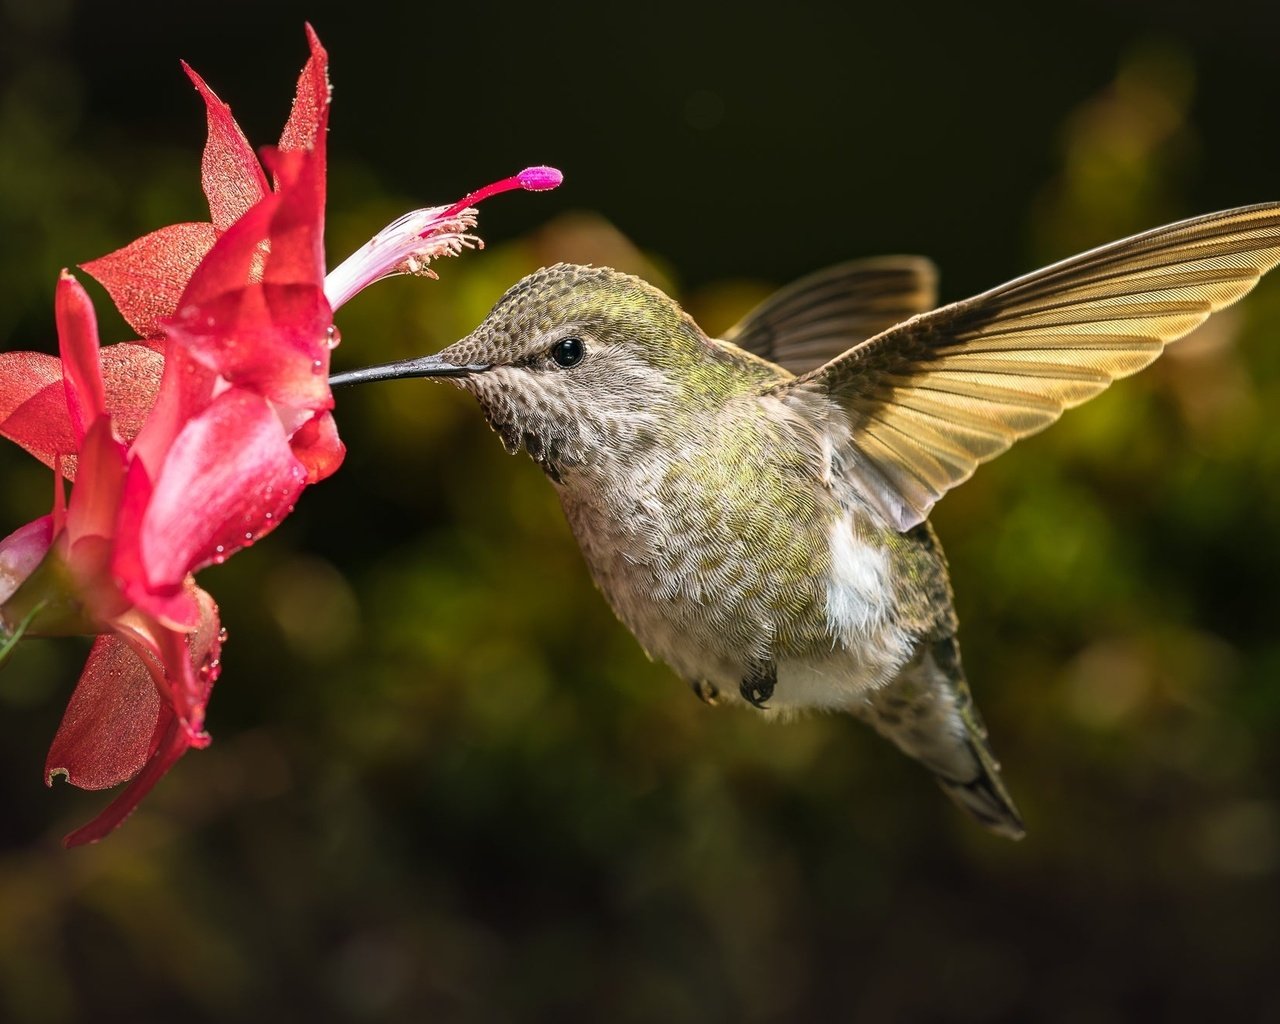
126, 389, 306, 604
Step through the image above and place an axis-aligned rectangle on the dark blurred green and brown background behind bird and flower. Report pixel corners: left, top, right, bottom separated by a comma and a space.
0, 0, 1280, 1024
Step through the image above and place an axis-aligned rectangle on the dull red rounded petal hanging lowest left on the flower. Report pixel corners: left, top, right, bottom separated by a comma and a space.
45, 636, 160, 790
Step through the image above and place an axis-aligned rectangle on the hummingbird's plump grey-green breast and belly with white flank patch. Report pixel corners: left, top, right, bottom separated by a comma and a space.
557, 389, 913, 709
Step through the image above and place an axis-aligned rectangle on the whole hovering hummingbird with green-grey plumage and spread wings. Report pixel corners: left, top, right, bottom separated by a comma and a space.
333, 204, 1280, 838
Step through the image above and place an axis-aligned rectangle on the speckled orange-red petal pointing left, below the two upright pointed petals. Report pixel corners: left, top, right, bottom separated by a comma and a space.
81, 221, 216, 338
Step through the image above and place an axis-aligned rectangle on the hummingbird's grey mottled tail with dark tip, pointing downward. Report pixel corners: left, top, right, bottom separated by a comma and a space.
852, 636, 1027, 840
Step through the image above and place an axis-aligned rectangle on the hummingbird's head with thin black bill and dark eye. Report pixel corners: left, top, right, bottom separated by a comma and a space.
333, 264, 742, 481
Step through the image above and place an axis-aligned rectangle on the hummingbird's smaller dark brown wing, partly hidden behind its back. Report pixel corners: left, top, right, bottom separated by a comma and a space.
722, 256, 938, 374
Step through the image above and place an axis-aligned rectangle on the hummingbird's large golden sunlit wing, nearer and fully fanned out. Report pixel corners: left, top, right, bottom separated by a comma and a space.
773, 204, 1280, 530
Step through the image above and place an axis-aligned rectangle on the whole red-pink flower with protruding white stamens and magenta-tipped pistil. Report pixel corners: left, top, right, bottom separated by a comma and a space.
0, 27, 559, 844
